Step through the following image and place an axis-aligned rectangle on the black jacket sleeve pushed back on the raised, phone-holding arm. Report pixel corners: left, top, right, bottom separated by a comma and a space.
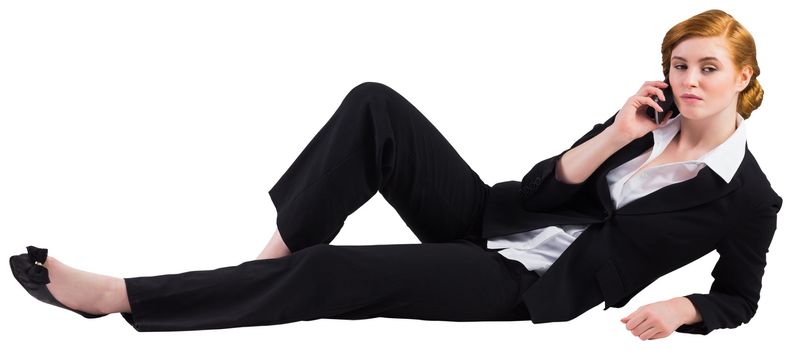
520, 111, 619, 212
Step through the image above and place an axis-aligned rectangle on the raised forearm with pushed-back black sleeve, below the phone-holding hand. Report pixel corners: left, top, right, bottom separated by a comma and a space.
520, 112, 629, 211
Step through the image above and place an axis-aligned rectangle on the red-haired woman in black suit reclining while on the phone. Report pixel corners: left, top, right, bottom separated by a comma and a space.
10, 10, 781, 339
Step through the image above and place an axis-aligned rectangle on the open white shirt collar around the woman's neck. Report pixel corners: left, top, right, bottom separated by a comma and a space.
650, 113, 747, 183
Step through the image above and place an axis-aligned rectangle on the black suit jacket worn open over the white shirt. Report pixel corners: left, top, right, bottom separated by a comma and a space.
482, 112, 782, 334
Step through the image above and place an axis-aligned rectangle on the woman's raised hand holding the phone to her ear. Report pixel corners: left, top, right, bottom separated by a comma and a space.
612, 81, 671, 140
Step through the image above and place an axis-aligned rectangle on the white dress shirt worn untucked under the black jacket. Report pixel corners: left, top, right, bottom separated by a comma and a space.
487, 114, 746, 276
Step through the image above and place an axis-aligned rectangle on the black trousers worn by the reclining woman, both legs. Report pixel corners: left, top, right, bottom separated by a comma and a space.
122, 82, 539, 331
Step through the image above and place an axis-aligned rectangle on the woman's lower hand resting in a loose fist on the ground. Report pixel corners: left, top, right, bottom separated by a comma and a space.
621, 299, 687, 340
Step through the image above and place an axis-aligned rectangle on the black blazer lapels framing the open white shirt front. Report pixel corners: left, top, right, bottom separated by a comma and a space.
596, 132, 747, 215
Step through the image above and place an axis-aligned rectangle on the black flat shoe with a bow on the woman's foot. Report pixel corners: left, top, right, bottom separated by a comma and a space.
9, 246, 107, 318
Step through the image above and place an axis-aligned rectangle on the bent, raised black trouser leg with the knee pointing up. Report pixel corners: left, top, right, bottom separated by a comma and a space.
269, 82, 489, 252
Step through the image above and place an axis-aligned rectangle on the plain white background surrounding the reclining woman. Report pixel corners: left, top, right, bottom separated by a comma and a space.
0, 0, 792, 349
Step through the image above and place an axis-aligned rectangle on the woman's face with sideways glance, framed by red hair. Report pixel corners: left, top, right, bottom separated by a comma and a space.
669, 37, 752, 119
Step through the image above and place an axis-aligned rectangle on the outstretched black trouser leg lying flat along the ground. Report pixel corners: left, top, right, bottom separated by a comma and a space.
122, 240, 538, 331
